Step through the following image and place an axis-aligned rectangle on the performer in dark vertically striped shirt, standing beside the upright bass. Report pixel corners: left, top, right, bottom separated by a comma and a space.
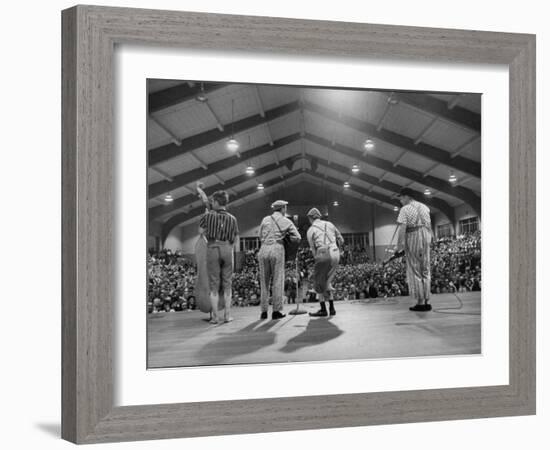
199, 191, 239, 324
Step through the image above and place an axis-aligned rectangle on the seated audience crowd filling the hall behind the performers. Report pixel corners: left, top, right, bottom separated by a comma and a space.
148, 232, 481, 312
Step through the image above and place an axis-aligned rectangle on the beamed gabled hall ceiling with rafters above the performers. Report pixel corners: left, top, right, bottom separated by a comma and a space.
147, 80, 481, 239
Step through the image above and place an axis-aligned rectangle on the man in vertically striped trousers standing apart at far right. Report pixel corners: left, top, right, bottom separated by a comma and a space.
396, 188, 432, 311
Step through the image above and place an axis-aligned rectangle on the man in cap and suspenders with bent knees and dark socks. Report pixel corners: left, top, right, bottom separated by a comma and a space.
307, 208, 344, 317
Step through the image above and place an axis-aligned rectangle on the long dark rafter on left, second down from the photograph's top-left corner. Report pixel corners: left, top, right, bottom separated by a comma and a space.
149, 101, 299, 165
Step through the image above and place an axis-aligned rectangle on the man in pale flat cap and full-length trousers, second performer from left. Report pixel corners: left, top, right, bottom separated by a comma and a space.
258, 200, 301, 320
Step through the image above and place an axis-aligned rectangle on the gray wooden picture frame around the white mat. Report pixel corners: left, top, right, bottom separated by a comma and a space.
62, 6, 535, 443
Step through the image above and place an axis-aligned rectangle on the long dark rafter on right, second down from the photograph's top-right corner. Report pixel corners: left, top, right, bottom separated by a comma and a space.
304, 101, 481, 178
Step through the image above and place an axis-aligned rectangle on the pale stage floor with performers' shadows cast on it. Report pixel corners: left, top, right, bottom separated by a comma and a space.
147, 292, 481, 368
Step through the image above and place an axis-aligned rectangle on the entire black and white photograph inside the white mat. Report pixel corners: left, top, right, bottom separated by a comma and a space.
147, 79, 483, 369
